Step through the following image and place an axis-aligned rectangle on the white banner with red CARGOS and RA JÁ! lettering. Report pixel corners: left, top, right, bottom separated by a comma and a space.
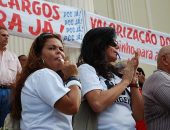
0, 0, 84, 47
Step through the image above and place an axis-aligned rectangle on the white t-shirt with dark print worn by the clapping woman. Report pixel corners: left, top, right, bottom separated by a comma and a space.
78, 64, 136, 130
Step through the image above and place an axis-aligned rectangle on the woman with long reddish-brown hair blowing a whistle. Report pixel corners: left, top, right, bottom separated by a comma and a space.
11, 33, 81, 130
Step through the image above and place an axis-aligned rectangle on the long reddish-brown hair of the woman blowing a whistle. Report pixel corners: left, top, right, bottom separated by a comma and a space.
11, 33, 62, 119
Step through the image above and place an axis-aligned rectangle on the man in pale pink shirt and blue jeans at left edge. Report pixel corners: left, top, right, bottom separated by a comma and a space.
0, 26, 21, 127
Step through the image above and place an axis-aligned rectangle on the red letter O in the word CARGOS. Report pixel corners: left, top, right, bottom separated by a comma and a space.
42, 3, 52, 18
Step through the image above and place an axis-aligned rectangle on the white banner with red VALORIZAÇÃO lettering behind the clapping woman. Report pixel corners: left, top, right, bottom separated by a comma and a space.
86, 12, 170, 65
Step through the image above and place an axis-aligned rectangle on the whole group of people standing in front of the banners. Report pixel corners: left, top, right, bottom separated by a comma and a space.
0, 27, 170, 130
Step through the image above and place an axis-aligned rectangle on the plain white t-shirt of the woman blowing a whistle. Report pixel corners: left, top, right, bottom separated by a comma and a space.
20, 68, 72, 130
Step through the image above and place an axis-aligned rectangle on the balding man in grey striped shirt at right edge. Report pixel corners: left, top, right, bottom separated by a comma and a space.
142, 45, 170, 130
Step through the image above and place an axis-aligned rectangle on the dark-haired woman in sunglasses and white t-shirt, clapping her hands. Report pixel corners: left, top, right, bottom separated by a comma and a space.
74, 27, 143, 130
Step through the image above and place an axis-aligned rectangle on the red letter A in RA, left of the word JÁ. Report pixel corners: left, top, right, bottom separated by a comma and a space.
8, 14, 22, 32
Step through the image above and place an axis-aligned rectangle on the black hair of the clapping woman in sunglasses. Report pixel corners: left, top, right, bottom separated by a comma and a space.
78, 27, 117, 79
